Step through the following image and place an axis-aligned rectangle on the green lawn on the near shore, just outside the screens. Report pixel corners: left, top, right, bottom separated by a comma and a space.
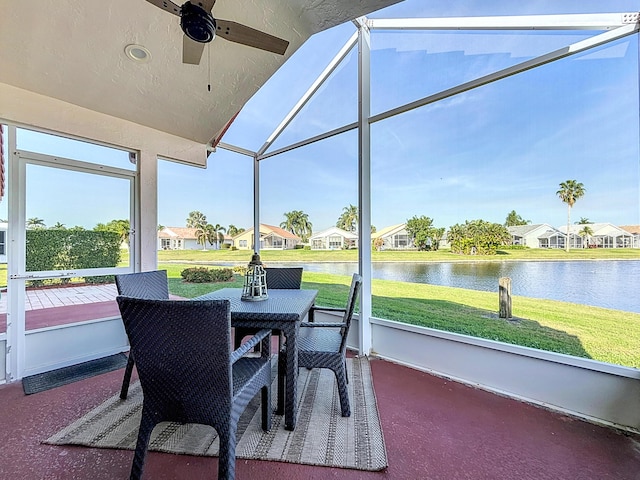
160, 264, 640, 368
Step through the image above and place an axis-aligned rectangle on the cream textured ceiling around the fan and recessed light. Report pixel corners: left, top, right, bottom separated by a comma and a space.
0, 0, 399, 144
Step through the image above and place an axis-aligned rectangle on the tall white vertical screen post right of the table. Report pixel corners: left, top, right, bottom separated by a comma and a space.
358, 19, 371, 355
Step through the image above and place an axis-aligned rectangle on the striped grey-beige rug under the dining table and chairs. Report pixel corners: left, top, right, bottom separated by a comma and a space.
44, 357, 387, 471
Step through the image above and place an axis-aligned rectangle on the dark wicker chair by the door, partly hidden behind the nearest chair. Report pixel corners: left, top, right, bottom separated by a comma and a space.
115, 270, 169, 400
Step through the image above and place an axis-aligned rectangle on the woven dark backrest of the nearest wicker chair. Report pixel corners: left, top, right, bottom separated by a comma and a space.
116, 296, 233, 425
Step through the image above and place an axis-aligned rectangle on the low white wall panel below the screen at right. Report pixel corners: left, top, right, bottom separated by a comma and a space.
318, 314, 640, 433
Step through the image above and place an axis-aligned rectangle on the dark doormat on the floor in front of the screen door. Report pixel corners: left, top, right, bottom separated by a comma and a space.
22, 353, 127, 395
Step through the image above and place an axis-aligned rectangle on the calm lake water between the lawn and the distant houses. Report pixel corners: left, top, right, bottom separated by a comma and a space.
262, 260, 640, 313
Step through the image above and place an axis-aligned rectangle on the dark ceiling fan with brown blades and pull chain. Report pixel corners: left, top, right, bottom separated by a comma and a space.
147, 0, 289, 65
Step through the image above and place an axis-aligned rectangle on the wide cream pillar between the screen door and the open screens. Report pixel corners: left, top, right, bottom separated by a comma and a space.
133, 150, 158, 272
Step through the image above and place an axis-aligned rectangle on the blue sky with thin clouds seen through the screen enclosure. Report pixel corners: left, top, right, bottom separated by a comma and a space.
0, 0, 640, 232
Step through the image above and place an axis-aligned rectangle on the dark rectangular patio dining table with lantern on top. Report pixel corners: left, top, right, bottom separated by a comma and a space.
196, 288, 318, 430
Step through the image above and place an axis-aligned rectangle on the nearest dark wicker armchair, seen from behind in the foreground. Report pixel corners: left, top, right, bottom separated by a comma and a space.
117, 296, 271, 480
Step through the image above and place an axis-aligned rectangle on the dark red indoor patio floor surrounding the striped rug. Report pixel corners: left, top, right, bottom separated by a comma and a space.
0, 354, 640, 480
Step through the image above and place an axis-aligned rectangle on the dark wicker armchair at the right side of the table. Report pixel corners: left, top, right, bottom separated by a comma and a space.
278, 273, 362, 417
